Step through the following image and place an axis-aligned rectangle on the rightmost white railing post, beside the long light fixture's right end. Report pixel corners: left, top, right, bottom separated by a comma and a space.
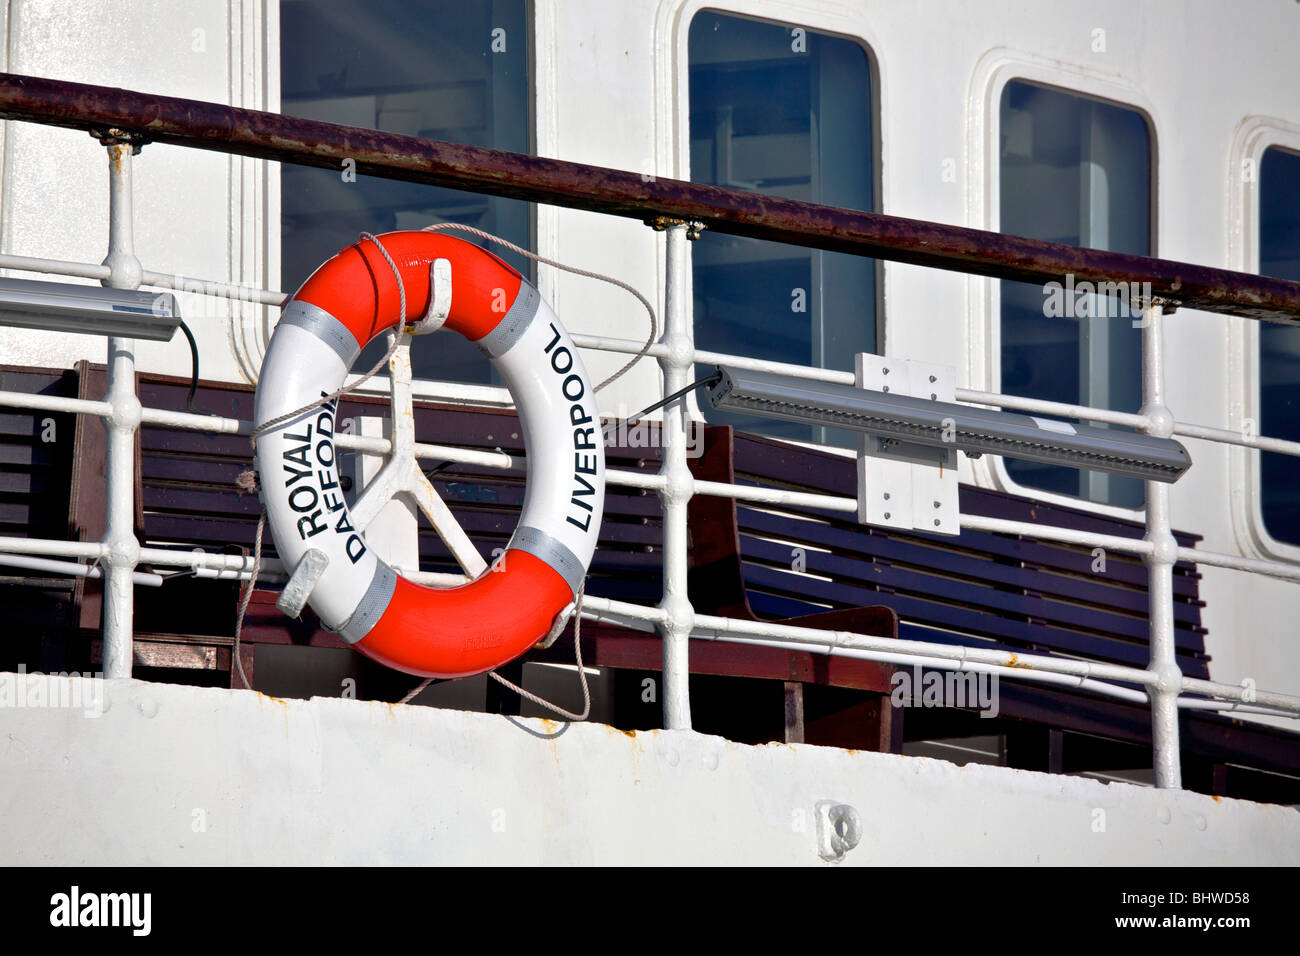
1141, 299, 1183, 790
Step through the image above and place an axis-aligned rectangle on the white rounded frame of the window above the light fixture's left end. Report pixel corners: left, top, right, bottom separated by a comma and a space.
657, 0, 888, 390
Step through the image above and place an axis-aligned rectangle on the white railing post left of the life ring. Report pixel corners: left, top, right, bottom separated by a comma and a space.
100, 130, 143, 678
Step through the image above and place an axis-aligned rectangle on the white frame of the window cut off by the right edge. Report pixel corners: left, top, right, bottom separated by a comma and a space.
1226, 116, 1300, 564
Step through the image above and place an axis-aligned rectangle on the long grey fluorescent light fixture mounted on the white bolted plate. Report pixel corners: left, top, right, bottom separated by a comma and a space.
709, 368, 1192, 481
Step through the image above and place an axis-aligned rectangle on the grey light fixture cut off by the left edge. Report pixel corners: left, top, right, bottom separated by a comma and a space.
0, 278, 181, 342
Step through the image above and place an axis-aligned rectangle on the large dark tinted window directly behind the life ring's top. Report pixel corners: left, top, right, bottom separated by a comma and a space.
280, 0, 532, 382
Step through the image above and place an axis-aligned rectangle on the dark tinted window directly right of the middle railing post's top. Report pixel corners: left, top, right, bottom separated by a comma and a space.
689, 10, 876, 444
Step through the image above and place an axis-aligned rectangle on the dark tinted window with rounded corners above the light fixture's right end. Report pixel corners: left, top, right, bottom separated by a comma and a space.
1000, 81, 1152, 507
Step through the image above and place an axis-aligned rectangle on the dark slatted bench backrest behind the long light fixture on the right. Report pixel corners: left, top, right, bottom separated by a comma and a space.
709, 426, 1209, 678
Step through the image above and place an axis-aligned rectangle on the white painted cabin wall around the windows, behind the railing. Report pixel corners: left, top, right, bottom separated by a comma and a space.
0, 0, 1300, 738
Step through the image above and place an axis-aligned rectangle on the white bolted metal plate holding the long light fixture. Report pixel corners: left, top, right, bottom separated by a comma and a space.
854, 352, 961, 535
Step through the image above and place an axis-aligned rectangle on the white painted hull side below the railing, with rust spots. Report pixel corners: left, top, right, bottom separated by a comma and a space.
0, 674, 1300, 866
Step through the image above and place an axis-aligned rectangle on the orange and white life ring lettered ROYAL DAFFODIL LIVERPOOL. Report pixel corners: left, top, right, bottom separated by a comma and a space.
255, 232, 605, 678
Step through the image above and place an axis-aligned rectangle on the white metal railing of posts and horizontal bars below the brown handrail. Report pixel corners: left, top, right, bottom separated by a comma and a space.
0, 140, 1300, 787
